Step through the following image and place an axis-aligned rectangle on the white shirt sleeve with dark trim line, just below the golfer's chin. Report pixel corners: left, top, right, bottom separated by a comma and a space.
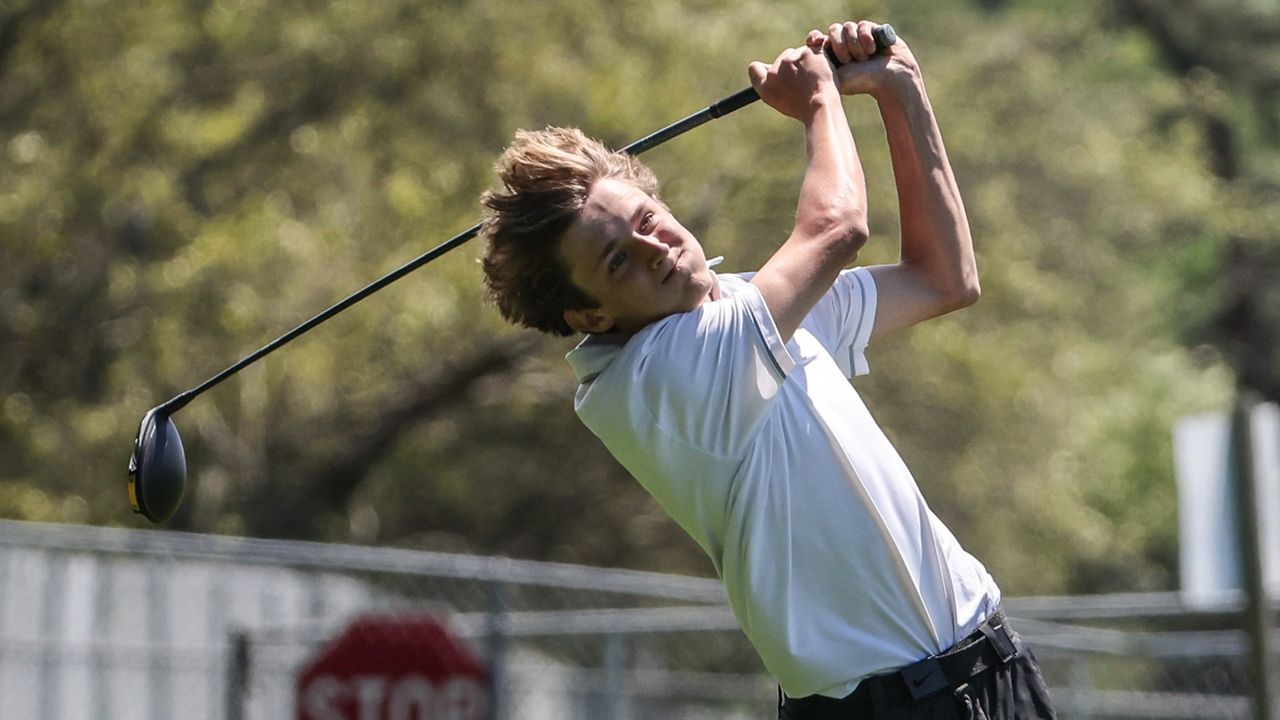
632, 277, 795, 457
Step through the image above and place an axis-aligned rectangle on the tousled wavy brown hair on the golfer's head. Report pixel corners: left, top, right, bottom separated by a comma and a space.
480, 127, 658, 336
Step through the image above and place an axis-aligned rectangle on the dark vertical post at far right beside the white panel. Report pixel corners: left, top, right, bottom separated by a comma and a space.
1230, 389, 1275, 720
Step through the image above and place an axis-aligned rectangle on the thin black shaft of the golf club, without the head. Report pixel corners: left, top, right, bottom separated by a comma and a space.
159, 87, 760, 415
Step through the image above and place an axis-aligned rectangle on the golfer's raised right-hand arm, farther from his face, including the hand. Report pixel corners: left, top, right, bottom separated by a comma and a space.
828, 23, 980, 337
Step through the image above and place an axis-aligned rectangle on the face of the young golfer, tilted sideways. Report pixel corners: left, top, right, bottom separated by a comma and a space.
561, 179, 714, 334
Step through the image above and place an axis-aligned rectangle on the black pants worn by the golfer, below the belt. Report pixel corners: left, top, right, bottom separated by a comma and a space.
778, 614, 1056, 720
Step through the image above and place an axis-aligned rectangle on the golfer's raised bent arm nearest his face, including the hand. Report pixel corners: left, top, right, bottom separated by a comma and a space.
748, 32, 867, 341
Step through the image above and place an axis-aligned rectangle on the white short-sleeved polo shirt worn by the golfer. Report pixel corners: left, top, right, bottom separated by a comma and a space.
568, 269, 1000, 697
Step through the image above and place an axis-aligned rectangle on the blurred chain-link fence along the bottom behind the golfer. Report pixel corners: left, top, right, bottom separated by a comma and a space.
0, 521, 1269, 720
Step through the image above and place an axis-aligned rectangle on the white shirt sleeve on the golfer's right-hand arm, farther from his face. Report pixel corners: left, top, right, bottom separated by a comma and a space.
800, 268, 876, 378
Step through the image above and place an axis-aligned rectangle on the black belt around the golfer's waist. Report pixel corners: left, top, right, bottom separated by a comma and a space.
782, 610, 1018, 720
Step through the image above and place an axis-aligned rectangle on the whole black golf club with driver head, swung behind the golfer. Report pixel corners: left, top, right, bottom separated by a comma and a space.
129, 24, 897, 523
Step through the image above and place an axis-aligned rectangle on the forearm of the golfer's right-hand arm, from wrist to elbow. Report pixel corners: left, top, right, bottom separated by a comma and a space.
877, 74, 979, 302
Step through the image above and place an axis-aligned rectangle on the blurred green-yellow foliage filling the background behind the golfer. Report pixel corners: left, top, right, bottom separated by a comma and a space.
0, 0, 1280, 717
